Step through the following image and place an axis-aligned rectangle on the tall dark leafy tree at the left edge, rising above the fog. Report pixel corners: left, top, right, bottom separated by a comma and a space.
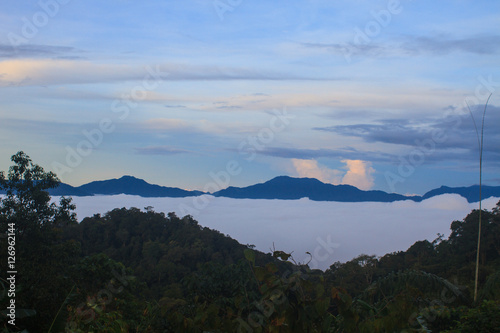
0, 151, 81, 332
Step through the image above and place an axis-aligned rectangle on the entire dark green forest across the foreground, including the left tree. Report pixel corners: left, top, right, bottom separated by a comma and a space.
0, 152, 500, 332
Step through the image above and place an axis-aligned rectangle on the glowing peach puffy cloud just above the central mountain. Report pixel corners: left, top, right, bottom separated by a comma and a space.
292, 159, 375, 190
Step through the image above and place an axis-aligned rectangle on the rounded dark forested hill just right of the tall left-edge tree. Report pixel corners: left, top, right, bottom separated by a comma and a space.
65, 208, 280, 298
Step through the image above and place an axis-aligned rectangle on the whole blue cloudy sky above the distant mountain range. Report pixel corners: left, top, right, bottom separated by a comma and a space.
0, 0, 500, 194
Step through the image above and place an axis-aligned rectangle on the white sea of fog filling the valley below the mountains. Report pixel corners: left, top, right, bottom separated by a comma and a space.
47, 194, 499, 269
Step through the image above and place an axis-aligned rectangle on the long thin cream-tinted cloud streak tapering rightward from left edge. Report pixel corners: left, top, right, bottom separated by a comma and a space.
0, 59, 338, 86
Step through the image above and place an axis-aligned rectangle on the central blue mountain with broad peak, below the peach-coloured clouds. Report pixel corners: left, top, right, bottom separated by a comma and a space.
213, 176, 414, 202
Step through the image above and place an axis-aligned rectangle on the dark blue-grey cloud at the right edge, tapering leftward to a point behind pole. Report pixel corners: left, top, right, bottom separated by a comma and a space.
313, 105, 500, 162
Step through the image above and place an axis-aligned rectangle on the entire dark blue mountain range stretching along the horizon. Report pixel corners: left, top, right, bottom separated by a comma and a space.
0, 176, 500, 203
